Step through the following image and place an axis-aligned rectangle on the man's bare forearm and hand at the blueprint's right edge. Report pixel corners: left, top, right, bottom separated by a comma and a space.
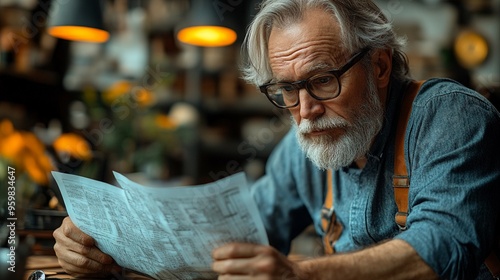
212, 239, 439, 280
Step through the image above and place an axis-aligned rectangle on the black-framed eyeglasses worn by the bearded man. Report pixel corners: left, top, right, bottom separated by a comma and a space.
259, 48, 370, 108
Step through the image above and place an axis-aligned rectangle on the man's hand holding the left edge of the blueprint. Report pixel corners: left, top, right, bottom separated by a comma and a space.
53, 217, 121, 277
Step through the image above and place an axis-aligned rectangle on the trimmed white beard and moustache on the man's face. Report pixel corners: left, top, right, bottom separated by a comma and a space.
292, 80, 384, 170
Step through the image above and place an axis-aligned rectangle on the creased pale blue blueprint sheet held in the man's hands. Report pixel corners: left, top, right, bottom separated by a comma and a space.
52, 172, 268, 279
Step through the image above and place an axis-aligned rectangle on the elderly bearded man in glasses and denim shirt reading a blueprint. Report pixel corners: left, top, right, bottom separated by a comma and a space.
54, 0, 500, 280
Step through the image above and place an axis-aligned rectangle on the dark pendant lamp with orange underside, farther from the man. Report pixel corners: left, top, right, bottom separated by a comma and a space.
48, 0, 109, 43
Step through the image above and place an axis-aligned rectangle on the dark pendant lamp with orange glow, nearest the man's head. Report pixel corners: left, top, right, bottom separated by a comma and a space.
177, 0, 237, 47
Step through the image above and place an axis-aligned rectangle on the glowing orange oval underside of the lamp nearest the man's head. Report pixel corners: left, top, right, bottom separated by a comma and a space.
177, 26, 237, 47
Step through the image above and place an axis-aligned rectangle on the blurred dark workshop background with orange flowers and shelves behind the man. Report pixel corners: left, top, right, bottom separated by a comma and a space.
0, 0, 500, 272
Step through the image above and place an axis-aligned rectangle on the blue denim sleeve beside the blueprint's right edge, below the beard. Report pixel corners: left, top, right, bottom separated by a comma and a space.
251, 129, 312, 254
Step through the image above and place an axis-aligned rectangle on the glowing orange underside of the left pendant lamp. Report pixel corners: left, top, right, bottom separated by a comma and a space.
48, 26, 109, 43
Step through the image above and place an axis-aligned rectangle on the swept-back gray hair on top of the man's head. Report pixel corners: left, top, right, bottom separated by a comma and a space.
241, 0, 409, 85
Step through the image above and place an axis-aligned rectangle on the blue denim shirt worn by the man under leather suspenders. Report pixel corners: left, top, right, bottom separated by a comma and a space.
252, 79, 500, 279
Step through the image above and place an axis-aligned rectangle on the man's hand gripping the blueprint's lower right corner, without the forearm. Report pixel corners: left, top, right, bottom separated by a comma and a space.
212, 243, 308, 280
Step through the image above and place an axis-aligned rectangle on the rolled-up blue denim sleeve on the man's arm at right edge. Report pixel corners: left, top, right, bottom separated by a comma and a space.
396, 80, 500, 279
